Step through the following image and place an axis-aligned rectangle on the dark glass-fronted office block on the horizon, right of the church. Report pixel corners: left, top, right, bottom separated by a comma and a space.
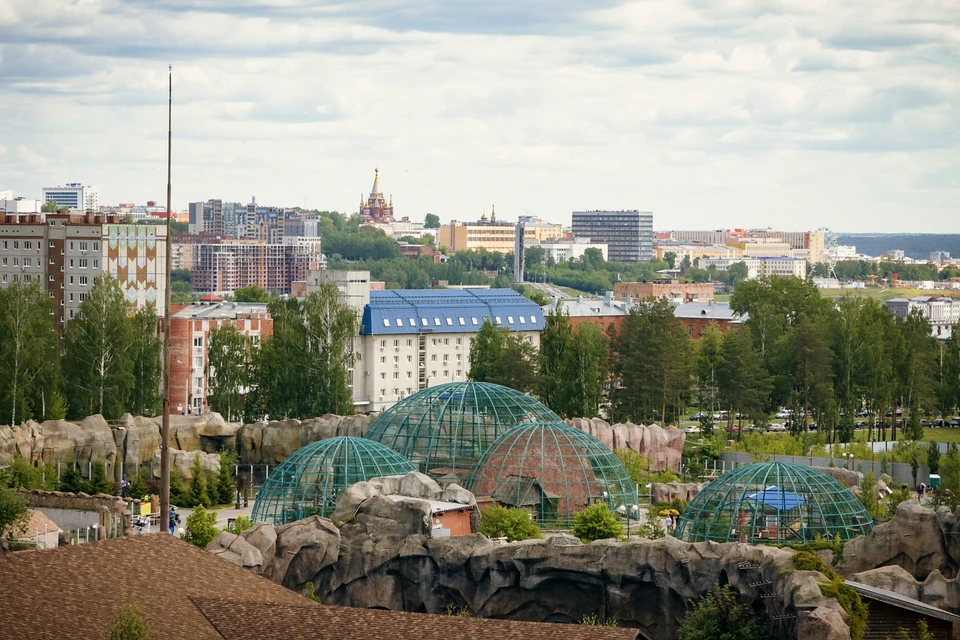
573, 210, 653, 262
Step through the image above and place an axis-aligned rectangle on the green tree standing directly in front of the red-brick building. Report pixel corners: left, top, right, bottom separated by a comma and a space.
206, 324, 251, 422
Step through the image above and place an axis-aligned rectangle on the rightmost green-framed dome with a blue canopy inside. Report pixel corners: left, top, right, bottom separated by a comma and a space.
674, 462, 873, 544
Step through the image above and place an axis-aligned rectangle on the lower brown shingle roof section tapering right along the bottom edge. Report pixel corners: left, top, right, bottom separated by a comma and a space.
194, 597, 637, 640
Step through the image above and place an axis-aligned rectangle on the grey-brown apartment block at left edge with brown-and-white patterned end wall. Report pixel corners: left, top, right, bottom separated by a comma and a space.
0, 213, 166, 330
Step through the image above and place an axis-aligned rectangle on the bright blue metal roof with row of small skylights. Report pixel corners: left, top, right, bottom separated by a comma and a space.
362, 289, 544, 335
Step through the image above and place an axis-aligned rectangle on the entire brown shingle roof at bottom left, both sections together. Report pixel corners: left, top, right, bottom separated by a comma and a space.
0, 533, 637, 640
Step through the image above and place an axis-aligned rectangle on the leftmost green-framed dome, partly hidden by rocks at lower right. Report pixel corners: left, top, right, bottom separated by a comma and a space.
251, 436, 416, 525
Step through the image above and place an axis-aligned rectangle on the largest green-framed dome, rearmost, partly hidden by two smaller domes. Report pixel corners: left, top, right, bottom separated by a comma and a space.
364, 382, 560, 484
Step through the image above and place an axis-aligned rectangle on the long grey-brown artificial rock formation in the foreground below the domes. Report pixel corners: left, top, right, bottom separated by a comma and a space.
216, 474, 850, 640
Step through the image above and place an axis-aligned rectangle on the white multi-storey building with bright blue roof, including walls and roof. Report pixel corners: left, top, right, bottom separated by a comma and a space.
353, 289, 544, 411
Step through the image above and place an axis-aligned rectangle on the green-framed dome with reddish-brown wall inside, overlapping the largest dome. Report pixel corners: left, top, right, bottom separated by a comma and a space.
470, 421, 638, 528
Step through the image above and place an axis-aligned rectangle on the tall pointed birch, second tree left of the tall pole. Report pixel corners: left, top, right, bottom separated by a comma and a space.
63, 274, 133, 420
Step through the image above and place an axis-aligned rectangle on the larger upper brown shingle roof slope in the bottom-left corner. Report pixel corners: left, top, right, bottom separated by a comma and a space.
0, 533, 309, 640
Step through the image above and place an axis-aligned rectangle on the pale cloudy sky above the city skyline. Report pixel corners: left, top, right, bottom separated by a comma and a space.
0, 0, 960, 232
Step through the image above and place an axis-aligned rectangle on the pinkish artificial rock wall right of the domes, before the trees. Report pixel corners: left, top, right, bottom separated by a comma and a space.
566, 418, 685, 471
